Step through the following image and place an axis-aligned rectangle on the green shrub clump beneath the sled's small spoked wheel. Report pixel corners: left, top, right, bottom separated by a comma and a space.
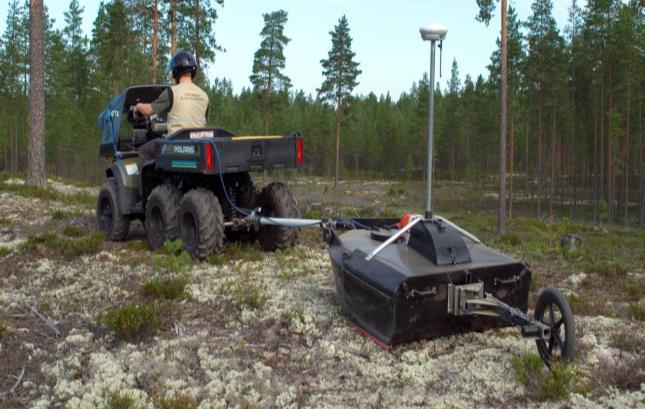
511, 353, 584, 401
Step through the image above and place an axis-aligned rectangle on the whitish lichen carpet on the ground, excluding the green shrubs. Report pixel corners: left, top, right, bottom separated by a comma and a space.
0, 180, 645, 408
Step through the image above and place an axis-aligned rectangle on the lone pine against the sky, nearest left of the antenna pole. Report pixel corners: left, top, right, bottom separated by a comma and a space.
318, 16, 361, 187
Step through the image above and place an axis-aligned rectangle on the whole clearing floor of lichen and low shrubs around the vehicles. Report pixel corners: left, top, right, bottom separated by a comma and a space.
0, 174, 645, 408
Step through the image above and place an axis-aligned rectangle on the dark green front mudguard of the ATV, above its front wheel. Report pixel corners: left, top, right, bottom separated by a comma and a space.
105, 157, 142, 215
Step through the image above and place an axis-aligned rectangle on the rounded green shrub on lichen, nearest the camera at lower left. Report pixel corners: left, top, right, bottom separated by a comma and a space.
103, 303, 162, 341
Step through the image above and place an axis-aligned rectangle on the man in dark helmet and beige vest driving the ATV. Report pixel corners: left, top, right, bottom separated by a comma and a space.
132, 51, 208, 164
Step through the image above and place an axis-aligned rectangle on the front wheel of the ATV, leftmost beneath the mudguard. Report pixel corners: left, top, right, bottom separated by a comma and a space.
96, 178, 130, 241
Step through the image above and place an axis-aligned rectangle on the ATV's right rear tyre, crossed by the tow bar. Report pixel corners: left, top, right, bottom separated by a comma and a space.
257, 183, 300, 251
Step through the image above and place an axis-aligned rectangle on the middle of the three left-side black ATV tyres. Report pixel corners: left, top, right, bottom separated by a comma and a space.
145, 185, 181, 249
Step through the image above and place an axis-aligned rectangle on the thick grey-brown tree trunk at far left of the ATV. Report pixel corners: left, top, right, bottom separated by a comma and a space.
27, 0, 46, 186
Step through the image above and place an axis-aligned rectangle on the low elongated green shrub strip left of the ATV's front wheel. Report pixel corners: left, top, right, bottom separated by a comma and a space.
21, 232, 105, 258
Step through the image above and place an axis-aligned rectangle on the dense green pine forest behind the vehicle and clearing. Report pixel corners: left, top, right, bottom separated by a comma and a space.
0, 0, 645, 225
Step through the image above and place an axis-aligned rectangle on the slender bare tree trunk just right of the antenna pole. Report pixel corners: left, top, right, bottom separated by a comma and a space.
497, 0, 508, 234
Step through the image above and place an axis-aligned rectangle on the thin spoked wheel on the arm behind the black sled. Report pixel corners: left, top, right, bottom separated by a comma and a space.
535, 287, 576, 367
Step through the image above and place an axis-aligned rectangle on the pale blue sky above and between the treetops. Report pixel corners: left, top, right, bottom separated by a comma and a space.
0, 0, 572, 98
